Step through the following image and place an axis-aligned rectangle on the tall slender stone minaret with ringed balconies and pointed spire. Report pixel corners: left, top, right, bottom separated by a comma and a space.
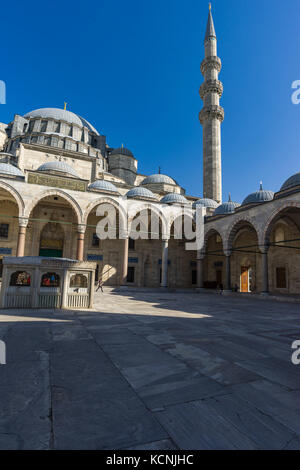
199, 4, 224, 203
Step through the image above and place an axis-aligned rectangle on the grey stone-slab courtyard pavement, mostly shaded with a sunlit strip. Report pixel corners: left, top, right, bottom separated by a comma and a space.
0, 290, 300, 450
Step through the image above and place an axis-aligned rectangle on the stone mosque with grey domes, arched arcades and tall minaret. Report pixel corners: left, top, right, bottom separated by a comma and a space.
0, 6, 300, 294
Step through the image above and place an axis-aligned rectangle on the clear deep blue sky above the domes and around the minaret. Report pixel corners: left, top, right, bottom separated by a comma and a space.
0, 0, 300, 202
